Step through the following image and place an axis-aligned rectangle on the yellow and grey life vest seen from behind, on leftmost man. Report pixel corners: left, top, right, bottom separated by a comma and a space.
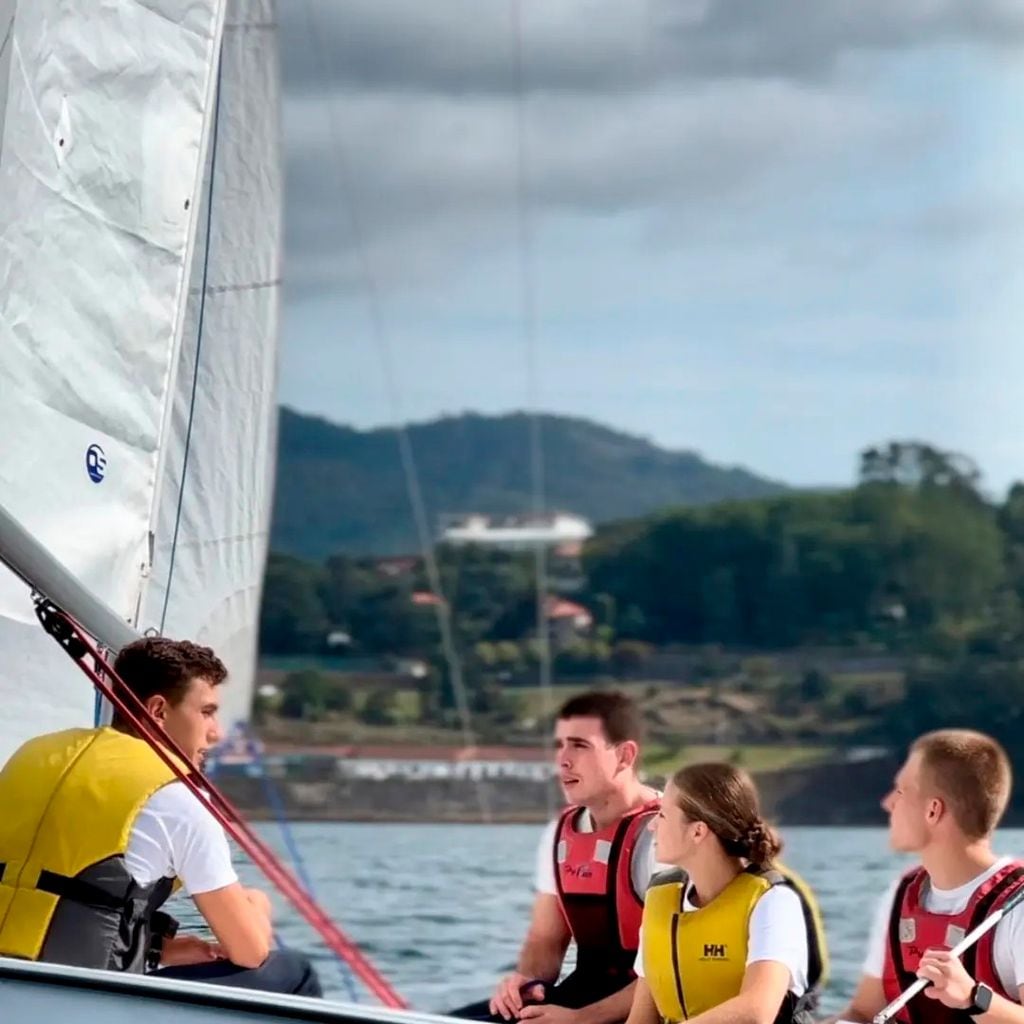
0, 727, 182, 970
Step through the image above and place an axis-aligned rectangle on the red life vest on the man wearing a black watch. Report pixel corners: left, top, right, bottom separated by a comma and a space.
882, 860, 1024, 1024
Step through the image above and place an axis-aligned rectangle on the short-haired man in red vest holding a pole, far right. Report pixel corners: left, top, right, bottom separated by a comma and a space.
841, 729, 1024, 1024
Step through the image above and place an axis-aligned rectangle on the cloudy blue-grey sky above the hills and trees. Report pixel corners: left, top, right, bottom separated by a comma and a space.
279, 0, 1024, 489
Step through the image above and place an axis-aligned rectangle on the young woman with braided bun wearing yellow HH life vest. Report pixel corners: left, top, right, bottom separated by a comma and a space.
628, 763, 826, 1024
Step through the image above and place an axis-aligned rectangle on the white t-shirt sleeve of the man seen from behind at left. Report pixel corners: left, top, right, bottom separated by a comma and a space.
125, 782, 239, 896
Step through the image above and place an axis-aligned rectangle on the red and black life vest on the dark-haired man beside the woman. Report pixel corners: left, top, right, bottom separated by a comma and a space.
554, 800, 659, 979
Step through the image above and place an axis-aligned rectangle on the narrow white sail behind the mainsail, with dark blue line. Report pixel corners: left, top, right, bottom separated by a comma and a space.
139, 0, 282, 724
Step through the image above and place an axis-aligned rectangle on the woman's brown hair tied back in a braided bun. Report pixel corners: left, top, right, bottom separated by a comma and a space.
672, 761, 782, 867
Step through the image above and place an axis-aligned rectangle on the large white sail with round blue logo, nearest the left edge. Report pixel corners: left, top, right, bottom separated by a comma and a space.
0, 0, 225, 760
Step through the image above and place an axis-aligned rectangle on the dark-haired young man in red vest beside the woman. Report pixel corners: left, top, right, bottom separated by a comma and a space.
456, 692, 658, 1024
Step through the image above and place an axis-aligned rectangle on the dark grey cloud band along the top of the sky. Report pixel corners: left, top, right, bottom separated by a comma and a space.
282, 0, 1024, 95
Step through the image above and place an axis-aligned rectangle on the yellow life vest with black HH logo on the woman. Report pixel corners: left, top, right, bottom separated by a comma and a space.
643, 867, 827, 1022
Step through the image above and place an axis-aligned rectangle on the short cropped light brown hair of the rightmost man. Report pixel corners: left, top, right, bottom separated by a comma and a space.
910, 729, 1013, 839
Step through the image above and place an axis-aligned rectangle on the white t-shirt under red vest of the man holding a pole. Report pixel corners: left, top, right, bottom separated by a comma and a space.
862, 857, 1024, 996
